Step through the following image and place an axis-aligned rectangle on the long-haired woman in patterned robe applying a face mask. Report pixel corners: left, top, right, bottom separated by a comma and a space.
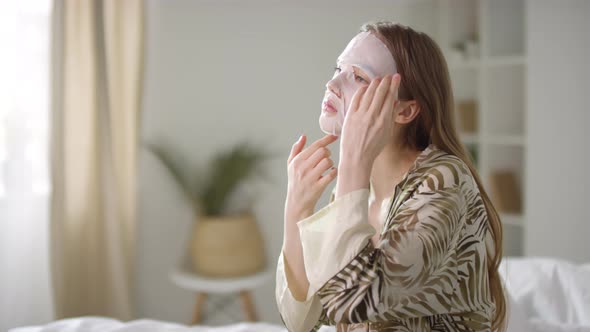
276, 22, 506, 332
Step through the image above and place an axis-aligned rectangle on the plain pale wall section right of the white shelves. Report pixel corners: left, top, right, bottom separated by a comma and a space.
525, 0, 590, 262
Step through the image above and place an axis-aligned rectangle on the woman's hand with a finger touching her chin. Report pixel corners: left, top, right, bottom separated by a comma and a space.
285, 135, 338, 223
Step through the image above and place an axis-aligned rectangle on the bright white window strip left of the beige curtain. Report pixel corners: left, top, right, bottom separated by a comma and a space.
0, 0, 53, 331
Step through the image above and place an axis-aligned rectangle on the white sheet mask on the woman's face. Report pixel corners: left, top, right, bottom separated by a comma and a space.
320, 32, 397, 136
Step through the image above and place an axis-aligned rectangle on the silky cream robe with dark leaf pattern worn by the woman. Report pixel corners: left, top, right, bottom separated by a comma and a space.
276, 144, 495, 332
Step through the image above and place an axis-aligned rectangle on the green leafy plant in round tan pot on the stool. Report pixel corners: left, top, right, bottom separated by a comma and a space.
149, 143, 276, 277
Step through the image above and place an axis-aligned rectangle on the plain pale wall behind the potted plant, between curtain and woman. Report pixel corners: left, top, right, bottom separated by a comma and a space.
136, 0, 437, 323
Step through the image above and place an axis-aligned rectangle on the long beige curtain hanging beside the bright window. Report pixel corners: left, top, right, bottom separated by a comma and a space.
51, 0, 144, 320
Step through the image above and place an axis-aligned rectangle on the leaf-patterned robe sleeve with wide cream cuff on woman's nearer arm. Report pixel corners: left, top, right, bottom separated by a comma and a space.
297, 176, 465, 324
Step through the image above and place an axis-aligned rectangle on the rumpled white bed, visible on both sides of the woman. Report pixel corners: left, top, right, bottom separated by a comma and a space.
9, 258, 590, 332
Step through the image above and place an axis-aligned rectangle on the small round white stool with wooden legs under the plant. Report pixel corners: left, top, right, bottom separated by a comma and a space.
170, 255, 275, 325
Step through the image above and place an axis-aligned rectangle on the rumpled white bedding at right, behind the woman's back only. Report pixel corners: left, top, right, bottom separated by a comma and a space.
500, 258, 590, 332
